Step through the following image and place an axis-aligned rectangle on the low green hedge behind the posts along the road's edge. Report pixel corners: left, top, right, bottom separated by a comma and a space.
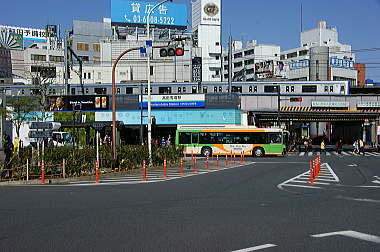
5, 145, 183, 176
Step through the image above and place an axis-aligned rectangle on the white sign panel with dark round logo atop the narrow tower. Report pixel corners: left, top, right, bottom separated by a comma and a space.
201, 0, 222, 25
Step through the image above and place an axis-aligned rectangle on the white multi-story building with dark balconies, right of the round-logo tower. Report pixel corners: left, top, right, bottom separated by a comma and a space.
223, 40, 280, 81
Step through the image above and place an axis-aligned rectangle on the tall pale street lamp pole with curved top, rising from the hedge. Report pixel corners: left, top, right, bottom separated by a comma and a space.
146, 0, 173, 165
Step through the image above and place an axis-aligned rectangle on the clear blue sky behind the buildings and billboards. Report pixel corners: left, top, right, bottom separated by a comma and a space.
0, 0, 380, 81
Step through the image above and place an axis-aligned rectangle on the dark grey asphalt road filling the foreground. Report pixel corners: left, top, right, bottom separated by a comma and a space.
0, 155, 380, 251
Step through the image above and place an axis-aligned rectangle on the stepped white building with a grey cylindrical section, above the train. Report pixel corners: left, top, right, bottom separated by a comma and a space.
280, 21, 357, 85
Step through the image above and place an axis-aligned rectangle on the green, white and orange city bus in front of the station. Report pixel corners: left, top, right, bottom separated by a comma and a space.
175, 125, 289, 157
